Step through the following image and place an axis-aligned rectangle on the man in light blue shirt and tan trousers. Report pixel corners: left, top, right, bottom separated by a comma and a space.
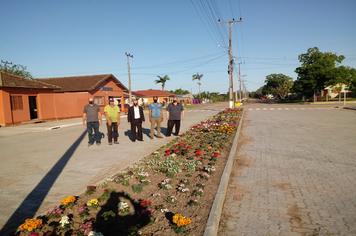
148, 96, 163, 139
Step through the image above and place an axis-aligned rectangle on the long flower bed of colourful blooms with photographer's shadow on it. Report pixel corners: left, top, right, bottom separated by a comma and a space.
17, 109, 241, 236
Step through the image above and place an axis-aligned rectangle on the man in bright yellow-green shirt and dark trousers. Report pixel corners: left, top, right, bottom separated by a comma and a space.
104, 98, 120, 145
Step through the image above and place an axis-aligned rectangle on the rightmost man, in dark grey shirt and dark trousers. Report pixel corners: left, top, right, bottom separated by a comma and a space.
167, 98, 184, 136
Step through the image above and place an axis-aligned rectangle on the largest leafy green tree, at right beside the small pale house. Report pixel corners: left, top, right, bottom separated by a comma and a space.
293, 47, 345, 97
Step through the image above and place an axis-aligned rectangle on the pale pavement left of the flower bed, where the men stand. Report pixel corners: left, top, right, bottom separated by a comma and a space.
0, 103, 227, 232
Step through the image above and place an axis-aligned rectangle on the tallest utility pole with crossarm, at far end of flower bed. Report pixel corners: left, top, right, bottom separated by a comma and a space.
218, 17, 242, 108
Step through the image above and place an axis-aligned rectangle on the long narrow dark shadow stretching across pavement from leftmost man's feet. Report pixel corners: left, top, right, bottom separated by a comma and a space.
0, 130, 87, 235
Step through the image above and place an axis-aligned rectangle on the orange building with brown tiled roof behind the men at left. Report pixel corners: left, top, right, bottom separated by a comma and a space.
0, 73, 127, 125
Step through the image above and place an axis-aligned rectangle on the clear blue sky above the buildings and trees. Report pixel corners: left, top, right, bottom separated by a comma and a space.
0, 0, 356, 93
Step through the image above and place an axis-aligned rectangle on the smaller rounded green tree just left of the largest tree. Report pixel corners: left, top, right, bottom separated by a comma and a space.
262, 74, 293, 99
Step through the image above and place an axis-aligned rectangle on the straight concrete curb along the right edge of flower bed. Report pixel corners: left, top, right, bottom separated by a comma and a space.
204, 110, 245, 236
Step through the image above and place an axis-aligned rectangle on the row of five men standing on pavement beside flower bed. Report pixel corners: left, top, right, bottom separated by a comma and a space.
83, 97, 184, 146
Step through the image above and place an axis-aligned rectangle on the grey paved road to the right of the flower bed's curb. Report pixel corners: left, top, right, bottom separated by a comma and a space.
219, 105, 356, 236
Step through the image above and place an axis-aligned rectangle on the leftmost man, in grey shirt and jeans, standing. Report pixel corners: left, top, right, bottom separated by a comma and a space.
83, 98, 101, 146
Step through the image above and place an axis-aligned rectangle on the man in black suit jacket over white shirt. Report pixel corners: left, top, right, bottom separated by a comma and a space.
127, 99, 145, 142
